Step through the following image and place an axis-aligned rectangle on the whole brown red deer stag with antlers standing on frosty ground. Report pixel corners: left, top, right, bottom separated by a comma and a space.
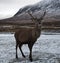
15, 11, 46, 61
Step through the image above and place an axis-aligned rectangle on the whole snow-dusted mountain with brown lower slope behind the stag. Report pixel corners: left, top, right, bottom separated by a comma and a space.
0, 0, 60, 26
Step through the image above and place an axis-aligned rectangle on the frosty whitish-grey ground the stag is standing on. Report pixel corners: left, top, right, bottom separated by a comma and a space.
0, 34, 60, 63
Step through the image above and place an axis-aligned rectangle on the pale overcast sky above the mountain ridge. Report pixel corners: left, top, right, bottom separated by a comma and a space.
0, 0, 41, 19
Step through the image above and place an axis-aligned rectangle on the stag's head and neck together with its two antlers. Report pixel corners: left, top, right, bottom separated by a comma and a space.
28, 11, 46, 37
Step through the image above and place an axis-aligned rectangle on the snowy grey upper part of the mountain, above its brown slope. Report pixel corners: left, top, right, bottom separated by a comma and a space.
14, 0, 60, 19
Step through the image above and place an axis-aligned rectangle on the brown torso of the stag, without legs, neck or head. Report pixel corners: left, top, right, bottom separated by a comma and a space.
15, 27, 41, 42
